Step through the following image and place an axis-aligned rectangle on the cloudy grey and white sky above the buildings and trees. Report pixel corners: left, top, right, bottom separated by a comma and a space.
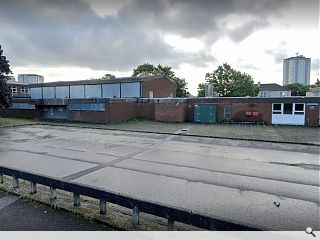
0, 0, 320, 94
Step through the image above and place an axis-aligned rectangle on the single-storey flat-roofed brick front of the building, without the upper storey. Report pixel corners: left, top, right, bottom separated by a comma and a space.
0, 94, 320, 126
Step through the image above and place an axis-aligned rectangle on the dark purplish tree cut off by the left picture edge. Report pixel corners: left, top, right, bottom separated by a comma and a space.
0, 45, 12, 109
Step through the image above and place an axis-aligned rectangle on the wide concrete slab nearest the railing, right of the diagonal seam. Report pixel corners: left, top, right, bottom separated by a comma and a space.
75, 167, 320, 231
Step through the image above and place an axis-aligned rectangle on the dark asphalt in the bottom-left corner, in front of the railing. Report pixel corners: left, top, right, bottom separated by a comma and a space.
0, 191, 112, 231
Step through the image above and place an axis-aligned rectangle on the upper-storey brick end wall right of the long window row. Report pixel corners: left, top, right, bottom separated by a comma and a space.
142, 78, 176, 98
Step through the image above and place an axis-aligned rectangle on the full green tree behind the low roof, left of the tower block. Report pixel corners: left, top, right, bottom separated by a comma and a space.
205, 63, 259, 97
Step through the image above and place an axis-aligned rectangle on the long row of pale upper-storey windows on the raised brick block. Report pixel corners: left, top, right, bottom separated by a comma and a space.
31, 82, 141, 99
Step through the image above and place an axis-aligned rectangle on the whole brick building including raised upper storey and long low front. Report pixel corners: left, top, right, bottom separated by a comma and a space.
0, 76, 320, 126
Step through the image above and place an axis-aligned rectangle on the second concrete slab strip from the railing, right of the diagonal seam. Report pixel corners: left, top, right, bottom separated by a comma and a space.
114, 159, 320, 204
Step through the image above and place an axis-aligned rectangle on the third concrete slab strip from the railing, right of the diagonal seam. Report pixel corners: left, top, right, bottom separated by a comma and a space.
133, 149, 319, 186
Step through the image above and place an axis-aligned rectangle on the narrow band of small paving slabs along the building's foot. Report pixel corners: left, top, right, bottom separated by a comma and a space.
42, 120, 320, 146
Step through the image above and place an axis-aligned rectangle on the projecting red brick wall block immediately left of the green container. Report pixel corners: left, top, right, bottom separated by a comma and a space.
155, 102, 187, 122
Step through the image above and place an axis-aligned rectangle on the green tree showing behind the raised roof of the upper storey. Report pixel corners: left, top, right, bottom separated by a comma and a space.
132, 63, 189, 97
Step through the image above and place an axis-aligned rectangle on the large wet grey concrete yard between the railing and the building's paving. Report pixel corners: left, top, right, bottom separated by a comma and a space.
0, 126, 320, 231
